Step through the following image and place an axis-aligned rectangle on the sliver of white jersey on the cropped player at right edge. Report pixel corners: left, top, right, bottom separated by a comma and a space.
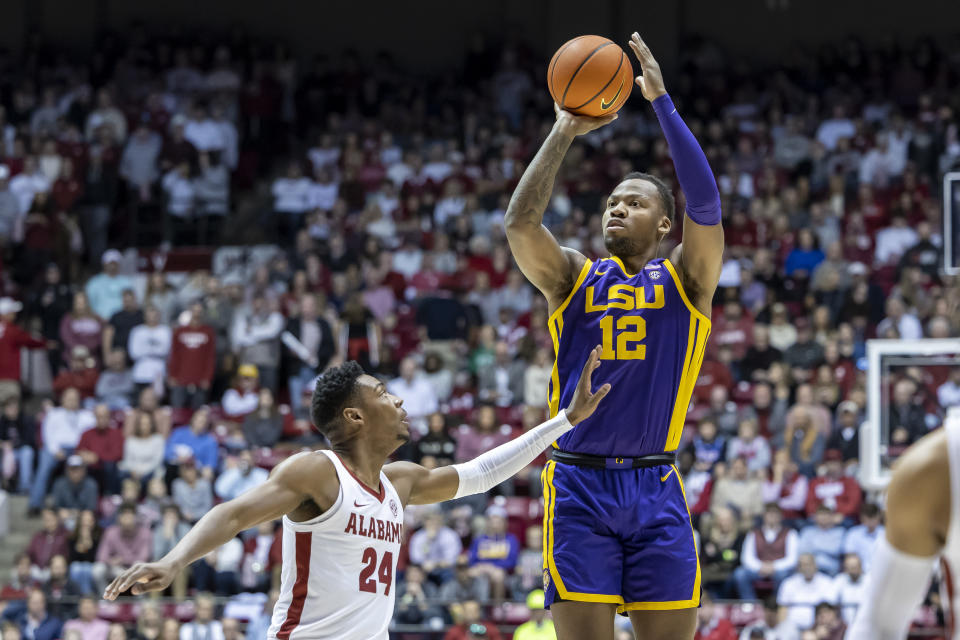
940, 411, 960, 640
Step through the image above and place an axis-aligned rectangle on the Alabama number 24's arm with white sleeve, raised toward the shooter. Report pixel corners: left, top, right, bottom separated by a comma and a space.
384, 346, 610, 504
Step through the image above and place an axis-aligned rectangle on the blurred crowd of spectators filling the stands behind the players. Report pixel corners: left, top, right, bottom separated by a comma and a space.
0, 25, 960, 640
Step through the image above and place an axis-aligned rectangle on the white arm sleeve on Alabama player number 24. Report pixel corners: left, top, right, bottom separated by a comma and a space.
453, 410, 573, 499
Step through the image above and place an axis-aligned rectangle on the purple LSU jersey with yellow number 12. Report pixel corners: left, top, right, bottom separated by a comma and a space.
548, 258, 710, 457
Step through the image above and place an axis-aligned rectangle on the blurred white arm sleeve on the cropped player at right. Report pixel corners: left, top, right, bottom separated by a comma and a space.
846, 536, 937, 640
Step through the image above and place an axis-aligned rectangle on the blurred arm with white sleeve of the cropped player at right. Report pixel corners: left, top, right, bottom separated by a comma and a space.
847, 429, 950, 640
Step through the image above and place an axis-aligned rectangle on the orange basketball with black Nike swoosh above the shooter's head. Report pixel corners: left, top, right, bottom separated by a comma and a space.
547, 36, 633, 117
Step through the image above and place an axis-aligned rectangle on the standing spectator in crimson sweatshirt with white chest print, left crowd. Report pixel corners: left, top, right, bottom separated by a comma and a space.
167, 302, 217, 409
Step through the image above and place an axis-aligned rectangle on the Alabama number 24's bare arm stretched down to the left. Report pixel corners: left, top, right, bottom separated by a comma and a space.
103, 454, 337, 600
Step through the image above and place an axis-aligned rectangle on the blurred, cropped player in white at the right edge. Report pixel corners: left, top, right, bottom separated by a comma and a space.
847, 411, 960, 640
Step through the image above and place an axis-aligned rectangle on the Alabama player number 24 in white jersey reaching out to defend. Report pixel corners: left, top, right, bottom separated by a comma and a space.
103, 347, 610, 640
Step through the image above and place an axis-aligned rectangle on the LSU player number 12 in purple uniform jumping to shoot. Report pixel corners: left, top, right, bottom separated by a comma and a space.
504, 33, 723, 640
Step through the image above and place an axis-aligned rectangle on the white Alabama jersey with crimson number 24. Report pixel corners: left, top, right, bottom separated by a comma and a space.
267, 451, 403, 640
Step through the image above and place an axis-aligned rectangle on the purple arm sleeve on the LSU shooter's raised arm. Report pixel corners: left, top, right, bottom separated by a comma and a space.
652, 94, 720, 225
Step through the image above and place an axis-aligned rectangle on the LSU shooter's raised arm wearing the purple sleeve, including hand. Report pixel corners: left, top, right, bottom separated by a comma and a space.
630, 32, 723, 316
